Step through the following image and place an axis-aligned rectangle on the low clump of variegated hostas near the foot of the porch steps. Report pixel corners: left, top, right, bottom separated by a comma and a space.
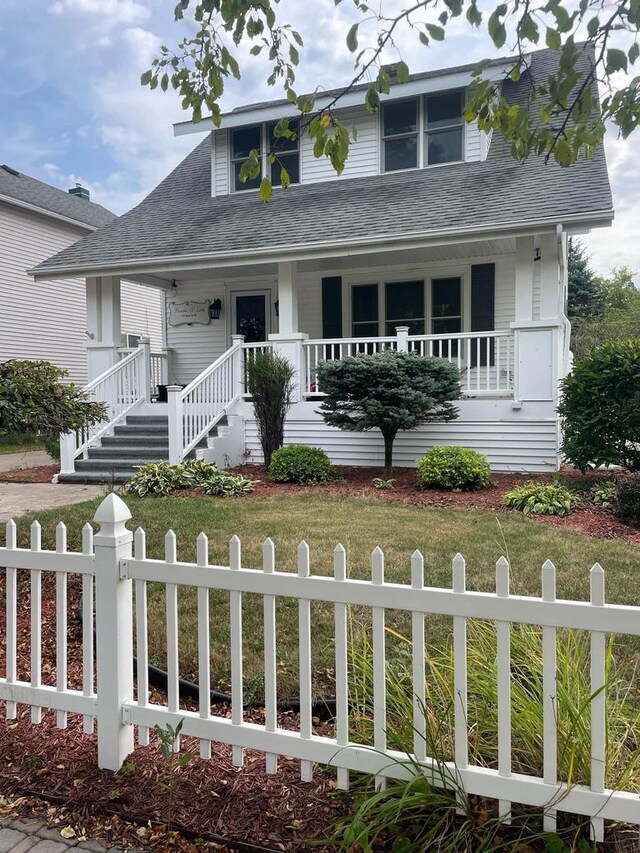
125, 459, 255, 498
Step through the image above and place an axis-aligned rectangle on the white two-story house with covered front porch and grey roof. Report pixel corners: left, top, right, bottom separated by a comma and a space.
33, 50, 613, 479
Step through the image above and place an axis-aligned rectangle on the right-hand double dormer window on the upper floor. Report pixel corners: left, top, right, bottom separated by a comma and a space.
382, 90, 464, 172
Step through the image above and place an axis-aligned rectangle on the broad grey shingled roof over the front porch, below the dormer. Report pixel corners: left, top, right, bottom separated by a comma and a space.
36, 45, 612, 274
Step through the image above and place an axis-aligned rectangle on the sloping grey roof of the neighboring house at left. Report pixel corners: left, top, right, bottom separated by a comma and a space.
0, 167, 116, 228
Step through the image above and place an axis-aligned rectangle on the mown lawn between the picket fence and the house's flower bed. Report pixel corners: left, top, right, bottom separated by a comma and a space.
10, 489, 640, 697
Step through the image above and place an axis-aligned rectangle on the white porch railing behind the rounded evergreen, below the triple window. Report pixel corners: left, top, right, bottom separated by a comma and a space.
303, 329, 514, 397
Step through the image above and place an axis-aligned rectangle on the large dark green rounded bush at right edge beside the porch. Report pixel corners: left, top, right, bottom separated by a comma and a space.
558, 338, 640, 471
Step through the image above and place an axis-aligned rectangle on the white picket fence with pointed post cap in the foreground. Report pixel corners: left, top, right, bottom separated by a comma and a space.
0, 494, 640, 839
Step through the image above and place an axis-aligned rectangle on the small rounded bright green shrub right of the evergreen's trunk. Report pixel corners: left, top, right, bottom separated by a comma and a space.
416, 446, 491, 492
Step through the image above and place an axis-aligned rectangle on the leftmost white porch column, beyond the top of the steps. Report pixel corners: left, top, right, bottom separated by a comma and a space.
86, 276, 121, 381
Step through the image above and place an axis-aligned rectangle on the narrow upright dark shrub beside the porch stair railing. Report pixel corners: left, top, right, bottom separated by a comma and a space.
246, 352, 294, 468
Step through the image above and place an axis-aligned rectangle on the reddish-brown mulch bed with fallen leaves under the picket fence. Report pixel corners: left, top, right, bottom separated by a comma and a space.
0, 573, 345, 853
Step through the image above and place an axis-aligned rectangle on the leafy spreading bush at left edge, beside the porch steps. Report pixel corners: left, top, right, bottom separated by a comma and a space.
0, 360, 105, 436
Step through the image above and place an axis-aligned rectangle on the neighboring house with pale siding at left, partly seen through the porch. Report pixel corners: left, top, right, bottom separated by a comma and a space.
0, 165, 164, 384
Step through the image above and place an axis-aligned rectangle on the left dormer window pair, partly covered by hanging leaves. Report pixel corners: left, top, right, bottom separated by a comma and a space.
231, 121, 300, 192
